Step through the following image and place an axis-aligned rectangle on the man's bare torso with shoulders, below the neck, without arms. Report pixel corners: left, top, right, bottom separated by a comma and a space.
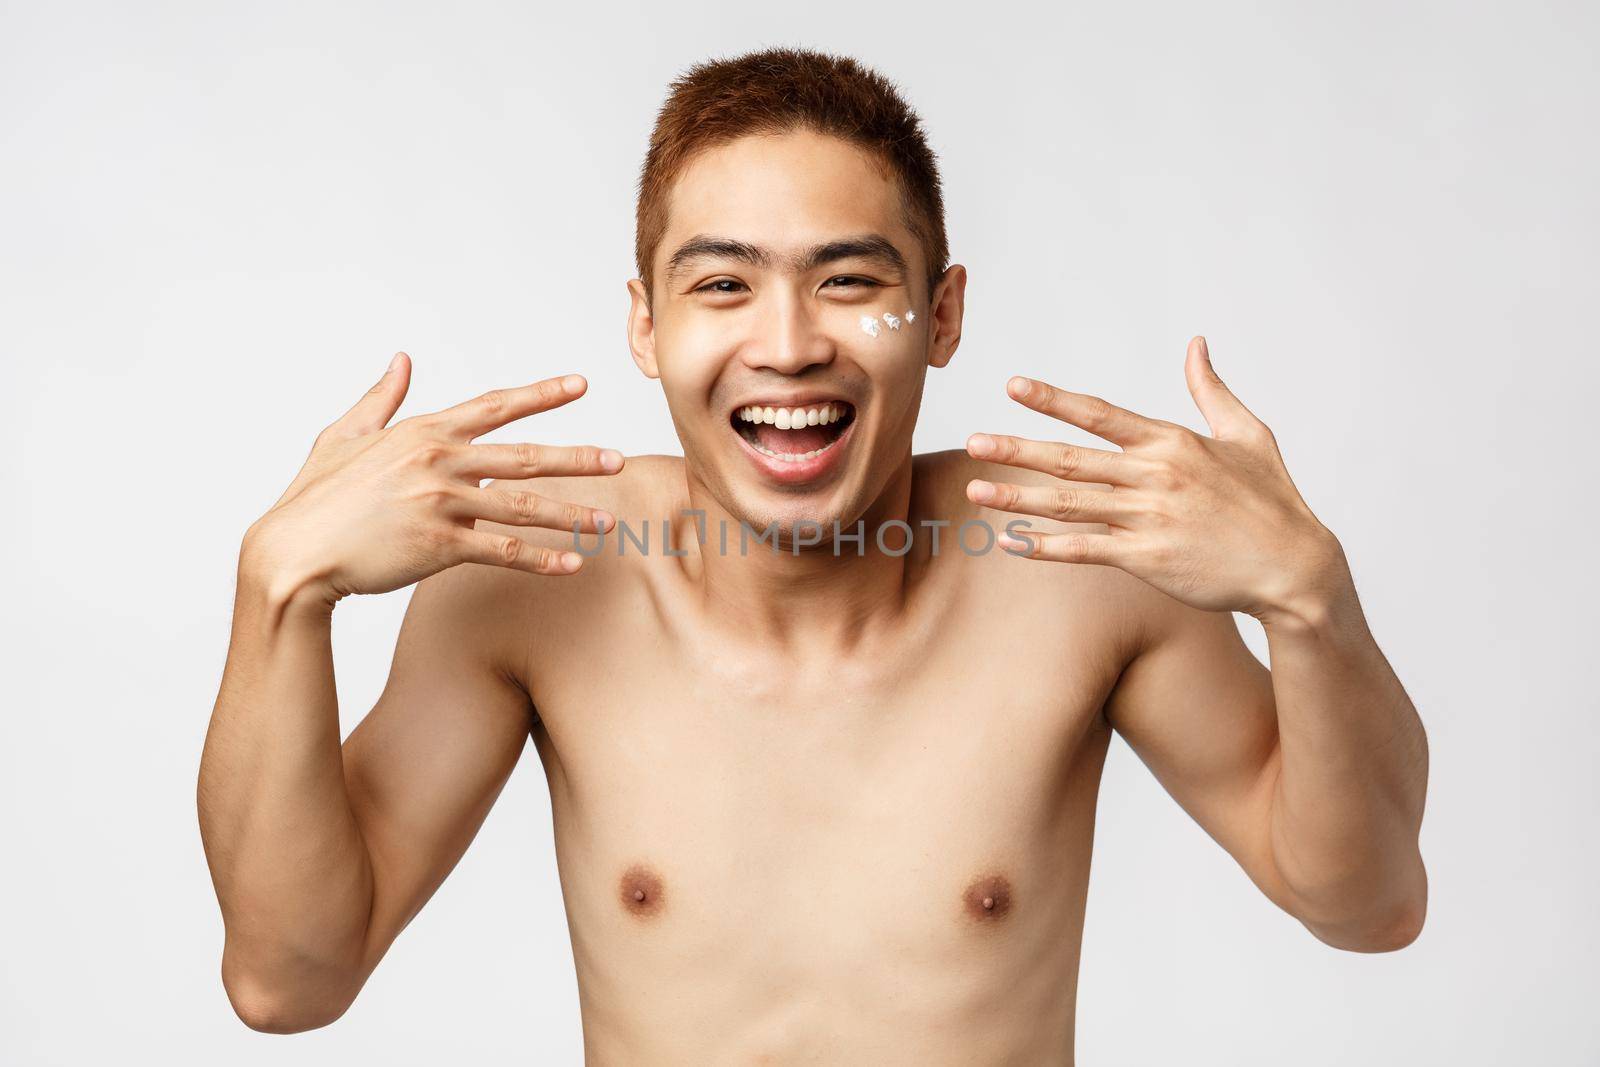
492, 453, 1138, 1064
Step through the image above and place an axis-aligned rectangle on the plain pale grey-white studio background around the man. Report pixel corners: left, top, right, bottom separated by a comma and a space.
0, 3, 1600, 1064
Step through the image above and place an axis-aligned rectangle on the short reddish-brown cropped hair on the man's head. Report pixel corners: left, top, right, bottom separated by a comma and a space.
634, 48, 950, 293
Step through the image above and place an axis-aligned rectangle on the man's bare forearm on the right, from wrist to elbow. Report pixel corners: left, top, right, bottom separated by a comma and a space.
1262, 552, 1427, 950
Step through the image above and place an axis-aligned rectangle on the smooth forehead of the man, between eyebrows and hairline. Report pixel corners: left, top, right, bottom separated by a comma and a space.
656, 130, 922, 269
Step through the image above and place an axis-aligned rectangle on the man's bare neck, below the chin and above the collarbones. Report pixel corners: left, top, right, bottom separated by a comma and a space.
672, 450, 915, 653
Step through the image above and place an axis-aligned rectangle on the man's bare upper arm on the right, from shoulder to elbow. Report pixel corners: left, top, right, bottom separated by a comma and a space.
1106, 597, 1286, 904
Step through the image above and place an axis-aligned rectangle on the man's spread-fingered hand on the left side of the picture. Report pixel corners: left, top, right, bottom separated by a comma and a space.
245, 352, 622, 603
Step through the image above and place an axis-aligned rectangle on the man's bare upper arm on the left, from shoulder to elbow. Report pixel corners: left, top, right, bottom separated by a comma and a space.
344, 565, 531, 965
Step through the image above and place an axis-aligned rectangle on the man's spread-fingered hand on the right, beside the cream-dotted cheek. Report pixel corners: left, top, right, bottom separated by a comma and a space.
966, 338, 1349, 617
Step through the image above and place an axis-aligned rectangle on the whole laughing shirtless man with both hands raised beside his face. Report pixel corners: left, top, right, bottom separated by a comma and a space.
198, 51, 1427, 1064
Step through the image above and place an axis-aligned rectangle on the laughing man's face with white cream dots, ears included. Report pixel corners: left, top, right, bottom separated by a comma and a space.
629, 131, 965, 536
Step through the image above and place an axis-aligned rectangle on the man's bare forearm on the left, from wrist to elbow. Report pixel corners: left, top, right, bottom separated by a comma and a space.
198, 541, 373, 1029
